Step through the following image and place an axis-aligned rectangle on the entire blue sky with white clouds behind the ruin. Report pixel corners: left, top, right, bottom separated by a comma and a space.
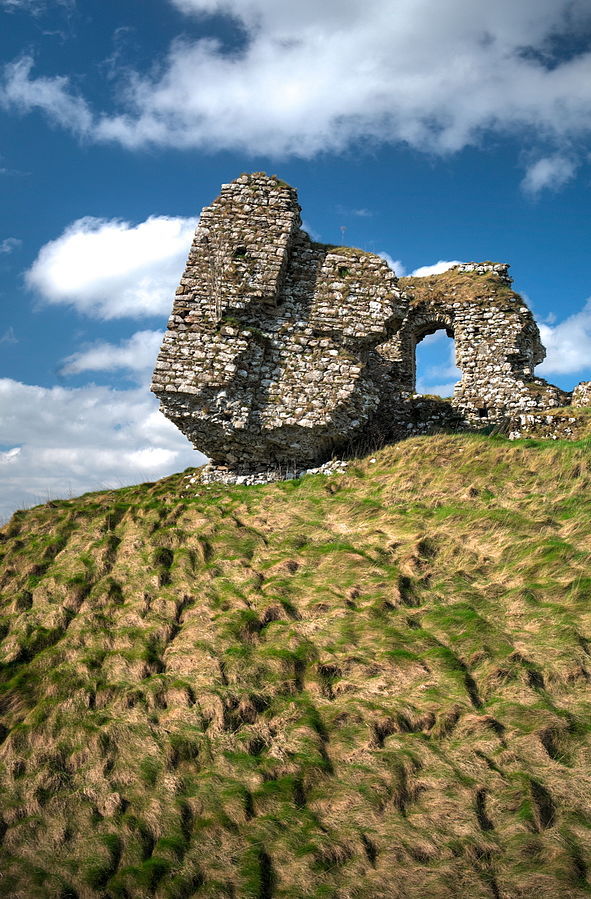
0, 0, 591, 518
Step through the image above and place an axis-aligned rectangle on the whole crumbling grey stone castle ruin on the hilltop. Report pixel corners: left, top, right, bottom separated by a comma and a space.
152, 172, 591, 474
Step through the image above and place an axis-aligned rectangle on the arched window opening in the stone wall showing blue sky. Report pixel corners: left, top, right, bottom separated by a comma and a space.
414, 323, 462, 398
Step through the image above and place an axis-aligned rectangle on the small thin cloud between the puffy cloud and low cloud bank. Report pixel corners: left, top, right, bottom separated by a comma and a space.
61, 331, 164, 375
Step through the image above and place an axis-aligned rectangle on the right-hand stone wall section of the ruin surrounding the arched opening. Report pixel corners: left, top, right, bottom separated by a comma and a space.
390, 263, 569, 424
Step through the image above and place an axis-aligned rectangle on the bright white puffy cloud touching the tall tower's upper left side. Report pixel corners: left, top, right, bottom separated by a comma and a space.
26, 216, 196, 319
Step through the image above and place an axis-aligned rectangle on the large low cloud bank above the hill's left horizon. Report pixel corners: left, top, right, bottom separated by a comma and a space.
0, 378, 204, 519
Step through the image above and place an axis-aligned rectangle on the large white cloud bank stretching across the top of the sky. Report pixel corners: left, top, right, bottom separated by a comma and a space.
3, 0, 591, 165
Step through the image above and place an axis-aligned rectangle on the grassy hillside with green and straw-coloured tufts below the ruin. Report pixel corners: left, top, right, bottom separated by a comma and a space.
0, 435, 591, 899
